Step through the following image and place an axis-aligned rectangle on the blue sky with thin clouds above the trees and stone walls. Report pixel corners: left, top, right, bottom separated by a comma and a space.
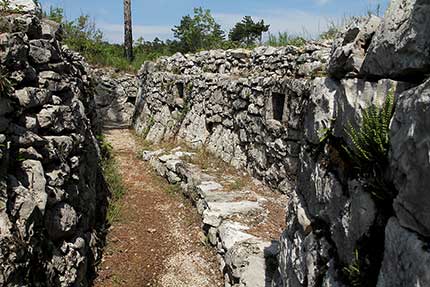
40, 0, 389, 43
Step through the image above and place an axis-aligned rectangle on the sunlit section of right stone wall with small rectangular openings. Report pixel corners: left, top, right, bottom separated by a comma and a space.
134, 43, 329, 191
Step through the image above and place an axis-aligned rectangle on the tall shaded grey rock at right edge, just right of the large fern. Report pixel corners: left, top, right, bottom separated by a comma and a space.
390, 78, 430, 236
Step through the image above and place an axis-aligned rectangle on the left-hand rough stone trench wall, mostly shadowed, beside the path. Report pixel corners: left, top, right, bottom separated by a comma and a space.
0, 7, 108, 286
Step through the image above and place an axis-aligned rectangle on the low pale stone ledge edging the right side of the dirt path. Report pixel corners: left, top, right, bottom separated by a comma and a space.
144, 148, 284, 287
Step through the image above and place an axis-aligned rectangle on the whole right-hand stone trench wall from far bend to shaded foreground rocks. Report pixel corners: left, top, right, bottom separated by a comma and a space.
133, 0, 430, 287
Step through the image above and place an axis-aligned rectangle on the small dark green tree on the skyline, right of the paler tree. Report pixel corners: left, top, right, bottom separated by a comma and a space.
229, 16, 270, 46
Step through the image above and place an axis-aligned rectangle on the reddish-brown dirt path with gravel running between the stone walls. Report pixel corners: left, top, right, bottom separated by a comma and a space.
95, 130, 223, 287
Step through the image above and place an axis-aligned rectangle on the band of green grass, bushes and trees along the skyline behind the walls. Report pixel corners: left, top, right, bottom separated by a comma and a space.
44, 7, 340, 71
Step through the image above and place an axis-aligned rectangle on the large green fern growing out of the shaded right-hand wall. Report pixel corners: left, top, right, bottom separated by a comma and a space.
344, 89, 395, 198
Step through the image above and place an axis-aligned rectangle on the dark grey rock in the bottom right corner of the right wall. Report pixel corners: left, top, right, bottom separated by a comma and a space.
377, 217, 430, 287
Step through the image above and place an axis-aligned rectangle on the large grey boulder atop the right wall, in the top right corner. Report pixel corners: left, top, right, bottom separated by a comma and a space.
362, 0, 430, 79
